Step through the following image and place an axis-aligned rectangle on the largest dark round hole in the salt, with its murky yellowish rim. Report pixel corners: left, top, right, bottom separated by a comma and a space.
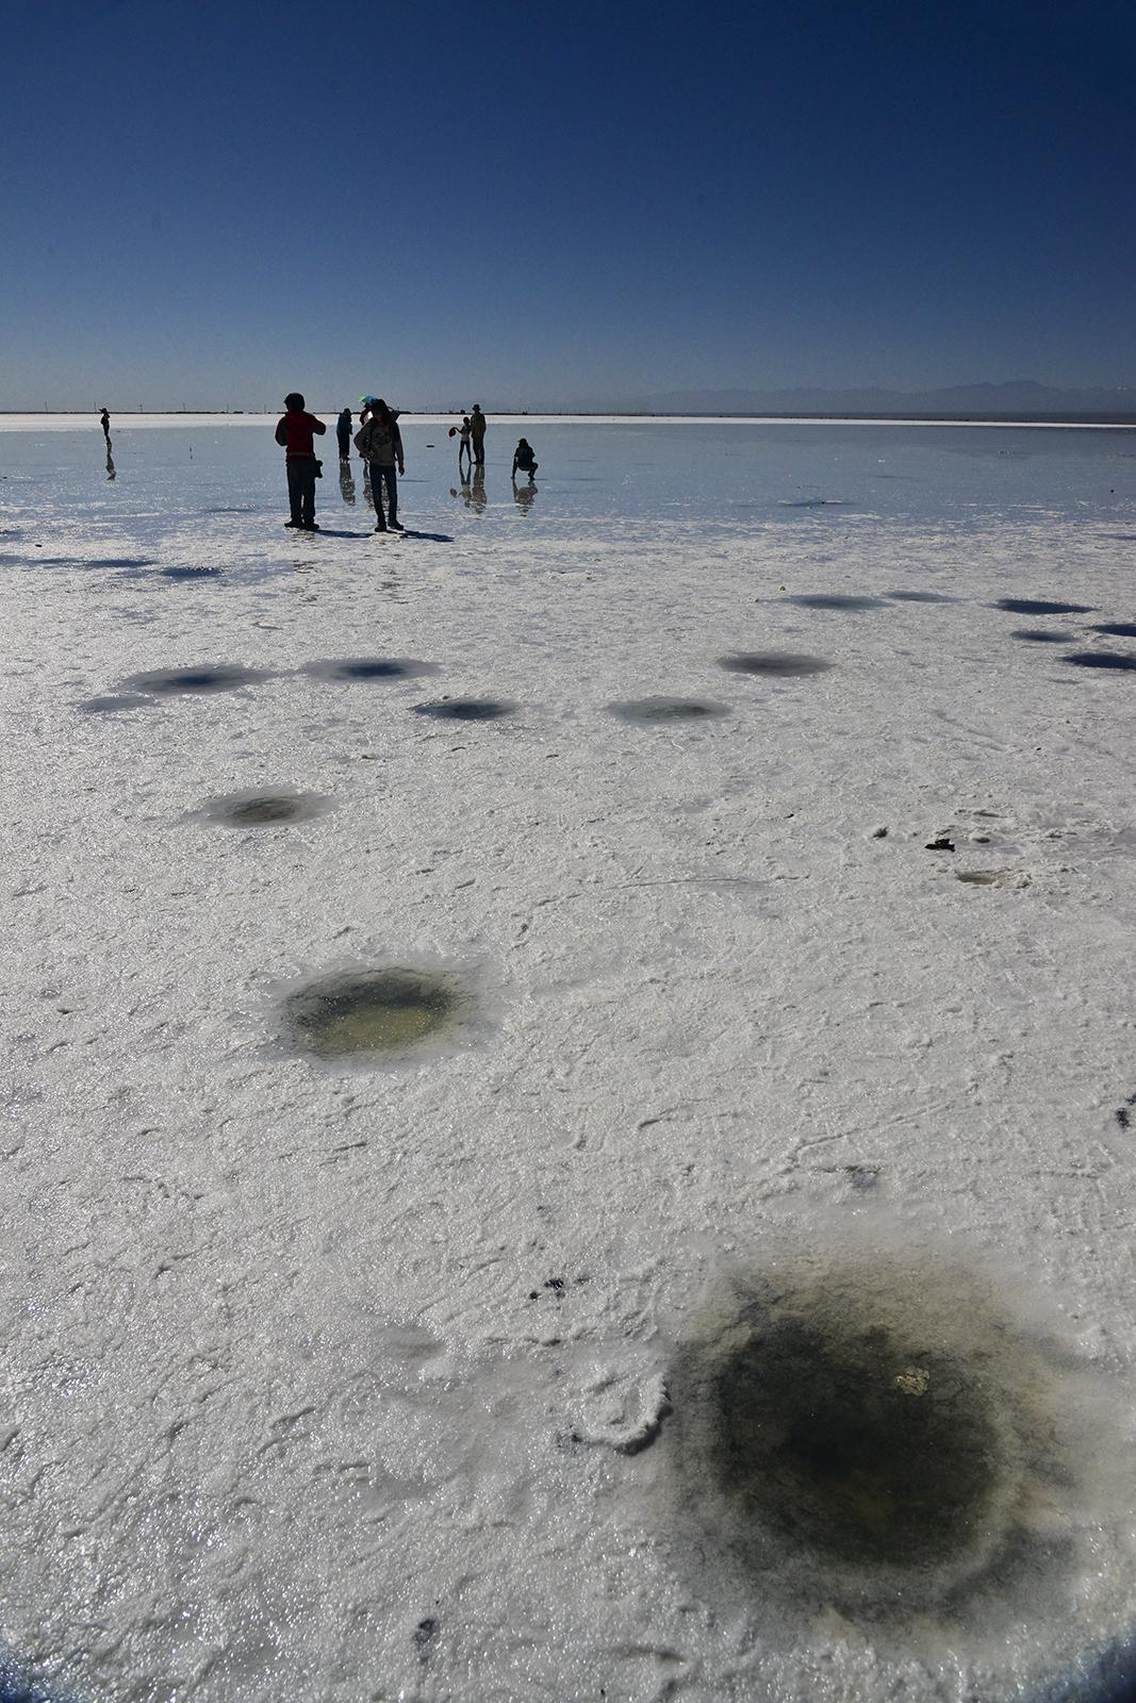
668, 1245, 1131, 1682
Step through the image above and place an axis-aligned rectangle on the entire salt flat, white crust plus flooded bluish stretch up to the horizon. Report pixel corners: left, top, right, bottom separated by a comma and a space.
0, 417, 1136, 1703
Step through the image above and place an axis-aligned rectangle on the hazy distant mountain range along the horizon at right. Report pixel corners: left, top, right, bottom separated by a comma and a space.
613, 378, 1136, 421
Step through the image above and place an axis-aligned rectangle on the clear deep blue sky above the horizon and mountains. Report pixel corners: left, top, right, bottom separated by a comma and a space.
0, 0, 1136, 409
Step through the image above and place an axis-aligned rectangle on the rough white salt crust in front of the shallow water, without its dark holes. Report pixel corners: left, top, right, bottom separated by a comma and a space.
0, 432, 1136, 1703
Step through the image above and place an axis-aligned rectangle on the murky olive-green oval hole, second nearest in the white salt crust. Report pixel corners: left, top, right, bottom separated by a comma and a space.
284, 967, 468, 1058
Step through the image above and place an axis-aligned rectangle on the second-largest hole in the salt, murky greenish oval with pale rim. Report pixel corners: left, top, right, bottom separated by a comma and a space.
281, 964, 479, 1064
